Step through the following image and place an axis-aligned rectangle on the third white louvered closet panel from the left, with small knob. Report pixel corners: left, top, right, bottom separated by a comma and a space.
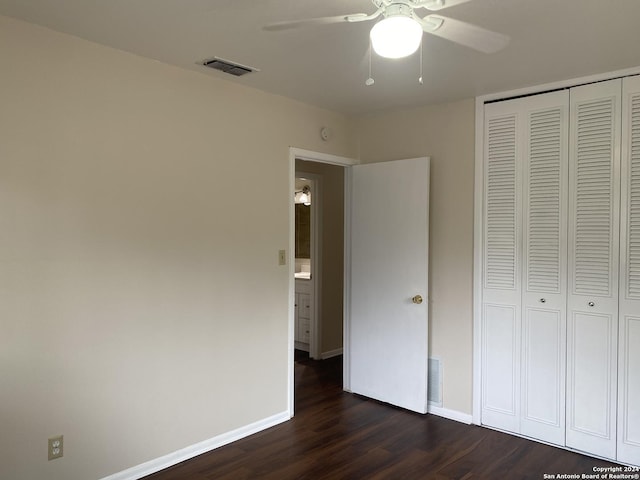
566, 80, 621, 458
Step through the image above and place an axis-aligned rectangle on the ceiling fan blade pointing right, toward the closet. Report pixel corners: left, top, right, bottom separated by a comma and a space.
422, 15, 509, 53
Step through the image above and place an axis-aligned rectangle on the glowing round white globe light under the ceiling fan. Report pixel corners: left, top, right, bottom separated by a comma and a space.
370, 15, 422, 58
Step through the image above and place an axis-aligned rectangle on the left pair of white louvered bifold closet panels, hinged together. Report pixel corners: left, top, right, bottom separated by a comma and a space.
481, 91, 569, 438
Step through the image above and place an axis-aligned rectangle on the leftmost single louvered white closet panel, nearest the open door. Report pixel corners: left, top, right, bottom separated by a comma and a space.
481, 102, 523, 432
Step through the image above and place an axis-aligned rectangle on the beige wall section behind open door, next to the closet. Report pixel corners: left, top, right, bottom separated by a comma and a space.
358, 99, 475, 414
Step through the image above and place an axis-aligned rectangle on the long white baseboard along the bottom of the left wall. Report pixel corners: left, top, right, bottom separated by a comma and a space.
102, 412, 291, 480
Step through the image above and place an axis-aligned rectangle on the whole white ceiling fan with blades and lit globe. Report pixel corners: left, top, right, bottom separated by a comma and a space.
264, 0, 509, 58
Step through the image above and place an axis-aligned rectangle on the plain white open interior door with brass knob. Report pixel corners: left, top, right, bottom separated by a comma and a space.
347, 158, 429, 413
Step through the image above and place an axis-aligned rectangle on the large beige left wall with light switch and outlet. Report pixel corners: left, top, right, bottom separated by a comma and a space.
0, 17, 357, 480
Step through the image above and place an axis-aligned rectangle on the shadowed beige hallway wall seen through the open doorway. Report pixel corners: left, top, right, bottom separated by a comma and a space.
296, 160, 344, 353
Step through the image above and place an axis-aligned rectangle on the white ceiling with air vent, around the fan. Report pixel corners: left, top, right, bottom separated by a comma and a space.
0, 0, 640, 113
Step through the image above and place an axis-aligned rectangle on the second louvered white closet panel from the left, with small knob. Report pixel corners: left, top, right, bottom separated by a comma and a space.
520, 90, 569, 445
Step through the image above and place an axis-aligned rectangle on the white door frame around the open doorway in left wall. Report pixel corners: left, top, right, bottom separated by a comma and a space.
287, 147, 360, 417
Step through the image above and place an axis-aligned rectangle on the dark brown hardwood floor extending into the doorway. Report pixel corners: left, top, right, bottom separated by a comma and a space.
145, 353, 615, 480
